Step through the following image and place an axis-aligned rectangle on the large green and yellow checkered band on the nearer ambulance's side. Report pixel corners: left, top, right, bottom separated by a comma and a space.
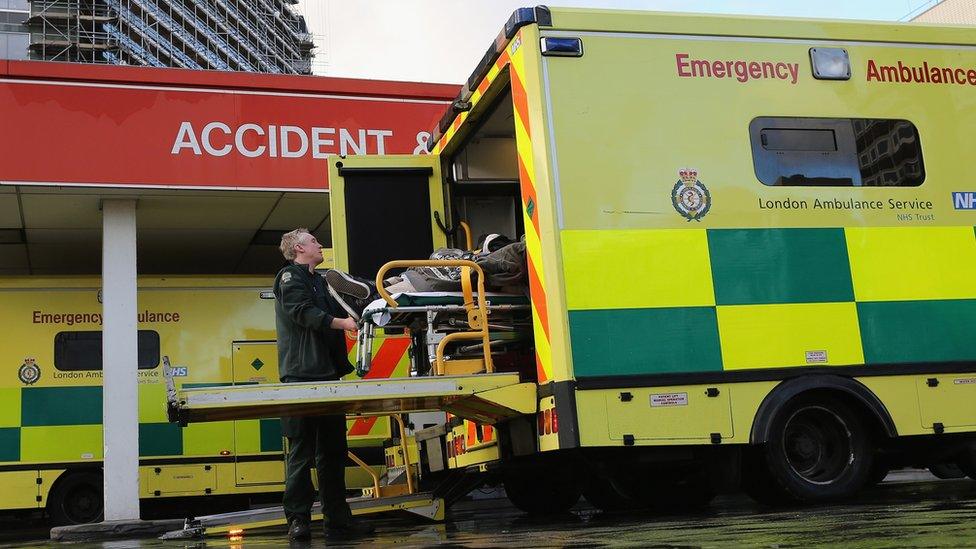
561, 226, 976, 377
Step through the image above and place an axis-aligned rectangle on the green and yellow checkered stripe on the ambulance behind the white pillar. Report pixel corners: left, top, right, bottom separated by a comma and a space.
0, 384, 282, 463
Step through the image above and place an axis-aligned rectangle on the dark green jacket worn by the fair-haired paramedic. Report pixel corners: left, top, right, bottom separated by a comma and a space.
274, 263, 353, 390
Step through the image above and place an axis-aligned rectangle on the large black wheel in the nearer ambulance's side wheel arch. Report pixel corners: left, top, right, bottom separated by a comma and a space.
753, 394, 874, 502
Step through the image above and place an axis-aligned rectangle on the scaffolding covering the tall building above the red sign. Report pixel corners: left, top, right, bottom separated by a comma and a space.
27, 0, 315, 74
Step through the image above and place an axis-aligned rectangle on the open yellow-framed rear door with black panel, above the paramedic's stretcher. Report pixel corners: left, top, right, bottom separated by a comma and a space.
329, 155, 447, 279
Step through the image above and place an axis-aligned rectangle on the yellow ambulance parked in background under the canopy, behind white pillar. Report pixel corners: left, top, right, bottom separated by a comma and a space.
0, 276, 406, 523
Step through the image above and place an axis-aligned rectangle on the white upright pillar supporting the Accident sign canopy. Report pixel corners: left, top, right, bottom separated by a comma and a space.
102, 199, 139, 521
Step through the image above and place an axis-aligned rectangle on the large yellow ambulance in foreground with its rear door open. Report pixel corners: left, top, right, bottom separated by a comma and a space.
320, 7, 976, 512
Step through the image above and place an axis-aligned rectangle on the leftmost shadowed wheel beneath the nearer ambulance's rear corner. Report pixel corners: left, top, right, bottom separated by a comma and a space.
503, 467, 582, 515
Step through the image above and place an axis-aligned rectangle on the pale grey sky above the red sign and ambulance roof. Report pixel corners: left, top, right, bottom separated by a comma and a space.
300, 0, 936, 83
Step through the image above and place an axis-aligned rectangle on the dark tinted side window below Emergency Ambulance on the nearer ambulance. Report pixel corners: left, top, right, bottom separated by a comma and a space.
749, 117, 925, 187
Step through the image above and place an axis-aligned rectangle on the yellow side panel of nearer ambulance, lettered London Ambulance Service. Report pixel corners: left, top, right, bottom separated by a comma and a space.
541, 30, 976, 445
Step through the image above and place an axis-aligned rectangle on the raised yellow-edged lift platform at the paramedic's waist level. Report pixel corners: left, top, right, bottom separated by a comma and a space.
166, 373, 537, 425
